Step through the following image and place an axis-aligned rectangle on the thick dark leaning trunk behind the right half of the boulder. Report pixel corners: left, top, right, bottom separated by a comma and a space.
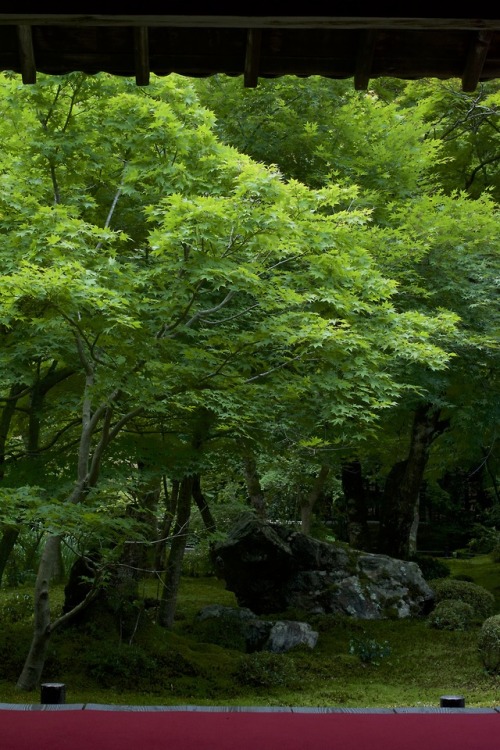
379, 404, 448, 560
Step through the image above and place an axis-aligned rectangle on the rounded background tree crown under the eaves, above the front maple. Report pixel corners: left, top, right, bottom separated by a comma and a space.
195, 75, 439, 201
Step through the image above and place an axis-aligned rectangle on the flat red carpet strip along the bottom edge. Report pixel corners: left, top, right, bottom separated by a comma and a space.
0, 709, 500, 750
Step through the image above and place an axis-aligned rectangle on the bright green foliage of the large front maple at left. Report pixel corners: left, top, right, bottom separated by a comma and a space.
0, 74, 454, 540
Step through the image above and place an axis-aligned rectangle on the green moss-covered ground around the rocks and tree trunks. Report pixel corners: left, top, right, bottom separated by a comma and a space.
0, 555, 500, 708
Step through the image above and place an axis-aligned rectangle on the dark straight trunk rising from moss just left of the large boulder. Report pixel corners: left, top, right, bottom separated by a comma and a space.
158, 477, 193, 629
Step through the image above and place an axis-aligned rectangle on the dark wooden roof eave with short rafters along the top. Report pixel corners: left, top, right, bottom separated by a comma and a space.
0, 13, 500, 92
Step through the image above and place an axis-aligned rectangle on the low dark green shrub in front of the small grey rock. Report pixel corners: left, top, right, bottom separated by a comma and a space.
235, 651, 298, 687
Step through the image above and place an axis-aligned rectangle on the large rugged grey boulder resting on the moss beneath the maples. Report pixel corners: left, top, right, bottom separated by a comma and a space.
211, 513, 433, 620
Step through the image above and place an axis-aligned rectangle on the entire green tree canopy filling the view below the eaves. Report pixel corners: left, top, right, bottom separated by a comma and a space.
0, 74, 499, 687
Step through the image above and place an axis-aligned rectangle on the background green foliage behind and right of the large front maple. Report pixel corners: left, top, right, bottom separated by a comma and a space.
196, 76, 500, 512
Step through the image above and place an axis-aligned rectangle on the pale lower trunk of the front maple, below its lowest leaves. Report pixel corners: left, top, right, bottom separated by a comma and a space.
17, 535, 60, 690
